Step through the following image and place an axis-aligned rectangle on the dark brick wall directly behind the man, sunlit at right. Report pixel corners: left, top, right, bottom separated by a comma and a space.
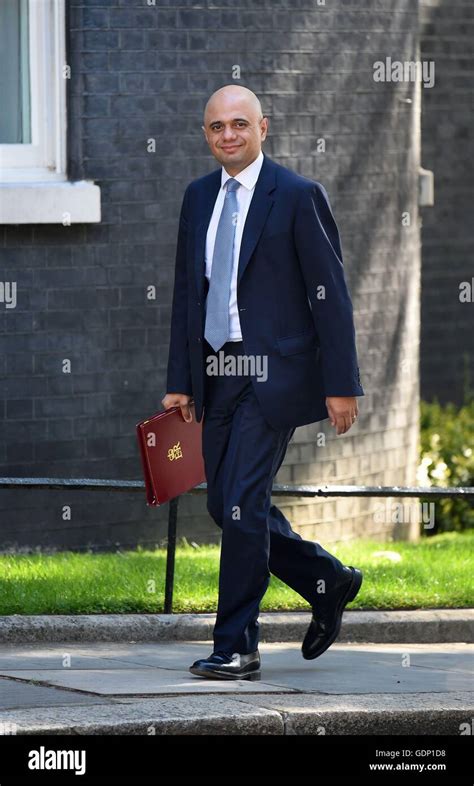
0, 0, 420, 548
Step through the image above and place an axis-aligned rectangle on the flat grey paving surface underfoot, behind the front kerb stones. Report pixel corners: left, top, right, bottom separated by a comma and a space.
0, 642, 468, 696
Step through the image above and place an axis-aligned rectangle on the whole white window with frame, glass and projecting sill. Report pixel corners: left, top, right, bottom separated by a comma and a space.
0, 0, 100, 223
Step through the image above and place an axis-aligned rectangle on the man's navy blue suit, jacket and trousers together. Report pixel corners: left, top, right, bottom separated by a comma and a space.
166, 156, 364, 654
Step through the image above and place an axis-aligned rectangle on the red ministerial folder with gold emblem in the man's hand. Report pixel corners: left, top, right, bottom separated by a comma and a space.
136, 404, 206, 506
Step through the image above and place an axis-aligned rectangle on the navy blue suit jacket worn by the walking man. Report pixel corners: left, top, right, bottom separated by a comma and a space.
166, 155, 364, 429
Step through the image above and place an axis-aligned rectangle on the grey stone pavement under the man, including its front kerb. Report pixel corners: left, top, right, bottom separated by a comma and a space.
0, 640, 474, 735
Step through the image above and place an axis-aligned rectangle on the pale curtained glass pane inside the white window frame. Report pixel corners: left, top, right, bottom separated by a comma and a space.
0, 0, 31, 144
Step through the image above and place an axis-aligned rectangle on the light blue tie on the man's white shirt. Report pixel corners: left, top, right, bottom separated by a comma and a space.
204, 177, 240, 352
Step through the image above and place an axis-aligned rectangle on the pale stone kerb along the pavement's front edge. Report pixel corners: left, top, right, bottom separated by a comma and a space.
0, 693, 474, 735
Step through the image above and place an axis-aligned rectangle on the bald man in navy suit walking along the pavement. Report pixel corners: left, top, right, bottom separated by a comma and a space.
162, 85, 364, 679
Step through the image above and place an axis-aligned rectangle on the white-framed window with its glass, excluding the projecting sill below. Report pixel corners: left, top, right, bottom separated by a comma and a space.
0, 0, 66, 182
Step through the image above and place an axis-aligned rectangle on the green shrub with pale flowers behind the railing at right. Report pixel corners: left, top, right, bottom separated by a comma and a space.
418, 398, 474, 535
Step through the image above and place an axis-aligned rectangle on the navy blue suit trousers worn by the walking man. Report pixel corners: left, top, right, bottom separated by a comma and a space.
202, 339, 343, 654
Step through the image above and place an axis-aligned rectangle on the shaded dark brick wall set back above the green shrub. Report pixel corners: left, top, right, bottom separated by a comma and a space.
420, 0, 474, 404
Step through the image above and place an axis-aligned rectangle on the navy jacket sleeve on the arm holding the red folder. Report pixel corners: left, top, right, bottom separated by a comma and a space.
166, 182, 193, 396
